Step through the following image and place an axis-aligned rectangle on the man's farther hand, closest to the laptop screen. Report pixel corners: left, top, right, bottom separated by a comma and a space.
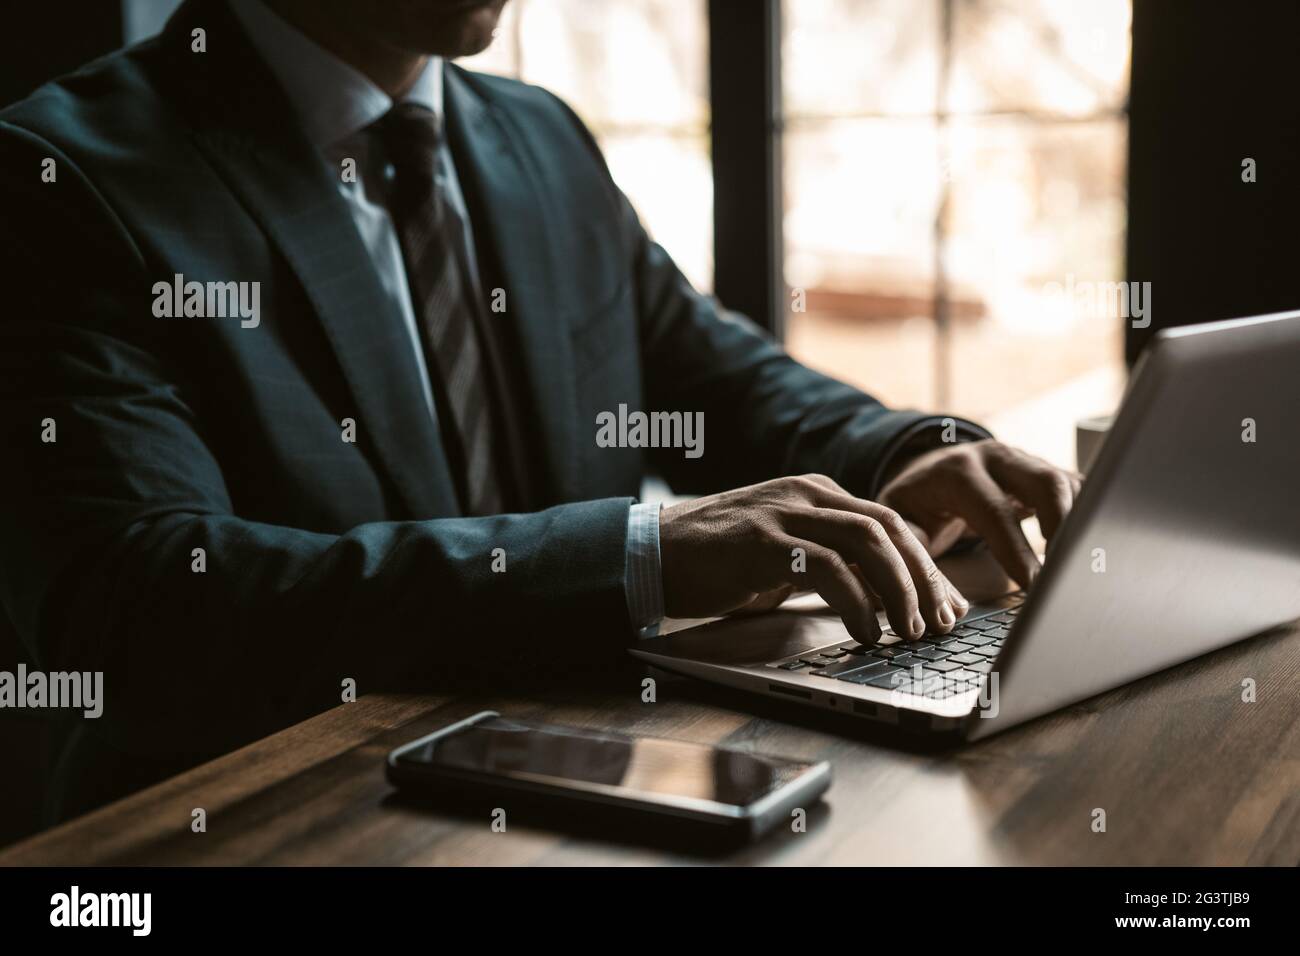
879, 440, 1080, 587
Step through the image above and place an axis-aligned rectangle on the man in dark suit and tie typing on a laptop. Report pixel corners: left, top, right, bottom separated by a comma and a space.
0, 0, 1076, 810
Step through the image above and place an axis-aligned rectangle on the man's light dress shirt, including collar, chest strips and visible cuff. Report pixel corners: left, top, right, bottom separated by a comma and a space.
230, 0, 663, 633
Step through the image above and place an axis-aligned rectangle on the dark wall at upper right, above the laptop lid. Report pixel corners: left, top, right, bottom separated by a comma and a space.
1127, 0, 1300, 362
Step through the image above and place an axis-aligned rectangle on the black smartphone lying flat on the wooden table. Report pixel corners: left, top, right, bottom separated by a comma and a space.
387, 710, 831, 843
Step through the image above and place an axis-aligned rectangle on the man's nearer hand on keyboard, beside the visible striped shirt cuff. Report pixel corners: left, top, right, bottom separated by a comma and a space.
659, 475, 969, 644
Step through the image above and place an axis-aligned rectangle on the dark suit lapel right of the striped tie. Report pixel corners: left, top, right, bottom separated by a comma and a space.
443, 66, 577, 502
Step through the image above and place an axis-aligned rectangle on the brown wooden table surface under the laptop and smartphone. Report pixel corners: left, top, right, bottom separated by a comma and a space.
0, 627, 1300, 865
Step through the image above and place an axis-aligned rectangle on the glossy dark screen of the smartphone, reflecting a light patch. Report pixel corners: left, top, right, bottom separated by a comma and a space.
397, 717, 810, 808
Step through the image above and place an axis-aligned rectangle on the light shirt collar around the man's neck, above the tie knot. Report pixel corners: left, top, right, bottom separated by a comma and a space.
230, 0, 442, 148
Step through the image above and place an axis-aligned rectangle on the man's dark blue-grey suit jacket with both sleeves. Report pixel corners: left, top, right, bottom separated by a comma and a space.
0, 0, 977, 822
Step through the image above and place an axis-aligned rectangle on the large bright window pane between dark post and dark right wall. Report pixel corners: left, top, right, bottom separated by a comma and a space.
781, 0, 1130, 464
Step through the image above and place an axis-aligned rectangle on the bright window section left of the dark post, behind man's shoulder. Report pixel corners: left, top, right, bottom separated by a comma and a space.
458, 0, 714, 291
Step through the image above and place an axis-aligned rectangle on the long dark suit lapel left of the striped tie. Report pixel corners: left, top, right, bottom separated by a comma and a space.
165, 0, 459, 518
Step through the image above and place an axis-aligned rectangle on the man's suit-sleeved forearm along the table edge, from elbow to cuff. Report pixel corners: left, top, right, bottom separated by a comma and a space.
17, 498, 631, 753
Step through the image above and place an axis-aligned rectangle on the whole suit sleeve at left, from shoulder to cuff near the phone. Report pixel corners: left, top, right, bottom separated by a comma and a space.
0, 124, 631, 753
